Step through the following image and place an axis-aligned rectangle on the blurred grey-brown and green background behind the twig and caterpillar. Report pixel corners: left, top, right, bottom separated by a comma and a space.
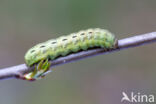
0, 0, 156, 104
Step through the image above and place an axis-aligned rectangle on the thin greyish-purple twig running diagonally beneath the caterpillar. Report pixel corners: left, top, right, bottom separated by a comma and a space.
0, 32, 156, 79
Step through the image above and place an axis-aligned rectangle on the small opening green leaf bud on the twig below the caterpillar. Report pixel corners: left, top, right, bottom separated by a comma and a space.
23, 59, 51, 81
